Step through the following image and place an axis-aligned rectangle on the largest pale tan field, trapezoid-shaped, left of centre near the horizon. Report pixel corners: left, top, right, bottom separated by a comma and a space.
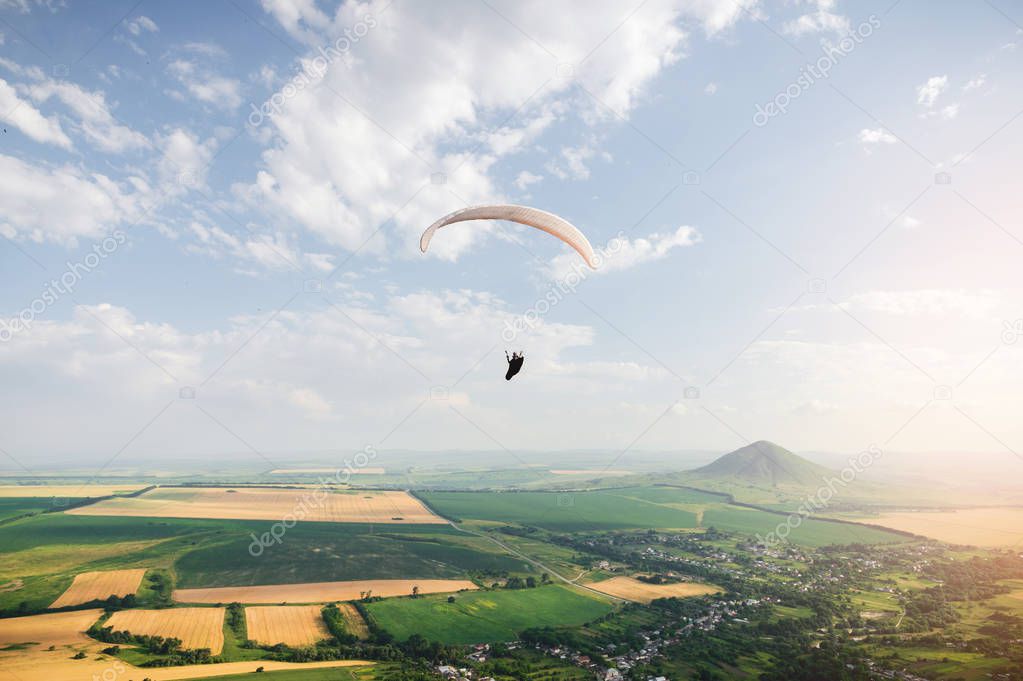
66, 487, 444, 524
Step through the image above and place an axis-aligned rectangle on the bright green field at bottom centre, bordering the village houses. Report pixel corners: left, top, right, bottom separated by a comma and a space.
366, 586, 613, 644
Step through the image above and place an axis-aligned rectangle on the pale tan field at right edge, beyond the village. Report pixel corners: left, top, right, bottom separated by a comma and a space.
860, 507, 1023, 546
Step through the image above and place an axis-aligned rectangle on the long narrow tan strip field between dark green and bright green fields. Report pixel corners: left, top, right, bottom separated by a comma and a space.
174, 580, 477, 603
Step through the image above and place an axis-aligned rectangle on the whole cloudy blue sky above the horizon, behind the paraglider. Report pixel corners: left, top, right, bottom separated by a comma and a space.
0, 0, 1023, 472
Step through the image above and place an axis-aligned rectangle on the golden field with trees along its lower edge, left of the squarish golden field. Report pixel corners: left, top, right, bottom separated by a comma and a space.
106, 607, 224, 654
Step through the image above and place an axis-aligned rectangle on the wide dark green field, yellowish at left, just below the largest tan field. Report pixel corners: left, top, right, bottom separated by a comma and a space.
0, 513, 531, 610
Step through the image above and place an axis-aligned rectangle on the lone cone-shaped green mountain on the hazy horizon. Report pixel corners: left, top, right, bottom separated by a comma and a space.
686, 440, 838, 488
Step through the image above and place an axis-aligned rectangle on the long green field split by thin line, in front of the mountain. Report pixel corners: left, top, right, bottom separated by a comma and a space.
420, 487, 904, 546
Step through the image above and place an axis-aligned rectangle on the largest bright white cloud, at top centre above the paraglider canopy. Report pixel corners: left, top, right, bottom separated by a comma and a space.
236, 0, 754, 258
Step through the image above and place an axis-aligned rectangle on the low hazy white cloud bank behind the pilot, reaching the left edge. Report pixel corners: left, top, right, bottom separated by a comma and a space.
0, 290, 674, 449
